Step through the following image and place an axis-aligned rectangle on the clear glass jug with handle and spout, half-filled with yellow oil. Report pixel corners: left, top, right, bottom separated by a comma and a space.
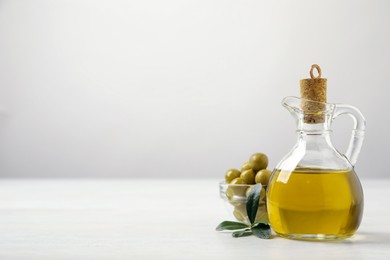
267, 97, 365, 240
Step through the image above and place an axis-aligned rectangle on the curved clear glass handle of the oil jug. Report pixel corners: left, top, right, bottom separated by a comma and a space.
333, 104, 366, 166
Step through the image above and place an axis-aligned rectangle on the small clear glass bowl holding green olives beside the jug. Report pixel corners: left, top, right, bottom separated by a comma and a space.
219, 181, 269, 224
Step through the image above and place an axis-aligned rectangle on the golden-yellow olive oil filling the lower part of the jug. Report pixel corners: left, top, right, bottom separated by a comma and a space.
267, 168, 363, 239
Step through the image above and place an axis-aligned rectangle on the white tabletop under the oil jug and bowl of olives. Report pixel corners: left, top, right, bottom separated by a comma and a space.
0, 179, 390, 260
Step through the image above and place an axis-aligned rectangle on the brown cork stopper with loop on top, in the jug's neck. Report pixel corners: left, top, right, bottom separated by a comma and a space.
300, 64, 327, 124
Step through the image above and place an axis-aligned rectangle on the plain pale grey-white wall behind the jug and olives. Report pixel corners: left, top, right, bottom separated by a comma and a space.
0, 0, 390, 178
